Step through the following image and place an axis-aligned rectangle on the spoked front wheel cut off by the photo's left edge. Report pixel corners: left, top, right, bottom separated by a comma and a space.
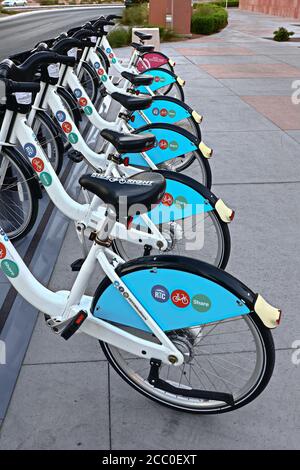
0, 148, 38, 240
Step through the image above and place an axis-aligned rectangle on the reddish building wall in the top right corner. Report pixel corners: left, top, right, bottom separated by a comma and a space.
240, 0, 300, 18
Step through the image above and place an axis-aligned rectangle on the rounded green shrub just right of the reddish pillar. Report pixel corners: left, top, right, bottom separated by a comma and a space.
191, 3, 228, 34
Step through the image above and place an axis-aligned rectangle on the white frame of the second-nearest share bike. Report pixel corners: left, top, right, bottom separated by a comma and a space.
0, 110, 168, 251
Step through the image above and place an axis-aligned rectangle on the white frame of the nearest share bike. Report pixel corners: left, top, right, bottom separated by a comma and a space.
0, 211, 184, 366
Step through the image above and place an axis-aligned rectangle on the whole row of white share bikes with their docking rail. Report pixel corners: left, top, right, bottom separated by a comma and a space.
0, 6, 281, 440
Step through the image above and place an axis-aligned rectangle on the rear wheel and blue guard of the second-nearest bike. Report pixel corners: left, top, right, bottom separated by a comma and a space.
113, 170, 231, 269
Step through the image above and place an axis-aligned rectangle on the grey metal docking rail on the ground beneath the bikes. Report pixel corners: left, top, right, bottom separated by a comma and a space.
0, 78, 113, 424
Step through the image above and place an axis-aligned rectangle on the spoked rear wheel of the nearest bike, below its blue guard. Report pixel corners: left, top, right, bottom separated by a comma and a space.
100, 313, 275, 414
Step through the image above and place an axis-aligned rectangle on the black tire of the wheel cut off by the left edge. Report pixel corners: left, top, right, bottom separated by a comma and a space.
0, 147, 41, 240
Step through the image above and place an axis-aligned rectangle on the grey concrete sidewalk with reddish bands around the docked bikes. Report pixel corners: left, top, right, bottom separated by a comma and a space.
0, 9, 300, 450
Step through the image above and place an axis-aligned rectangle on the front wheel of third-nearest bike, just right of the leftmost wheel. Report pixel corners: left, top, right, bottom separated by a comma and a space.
32, 110, 65, 175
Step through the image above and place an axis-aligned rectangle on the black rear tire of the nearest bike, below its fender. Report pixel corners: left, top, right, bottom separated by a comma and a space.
99, 312, 275, 415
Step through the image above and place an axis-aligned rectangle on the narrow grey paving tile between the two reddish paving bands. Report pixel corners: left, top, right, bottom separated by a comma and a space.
220, 78, 295, 96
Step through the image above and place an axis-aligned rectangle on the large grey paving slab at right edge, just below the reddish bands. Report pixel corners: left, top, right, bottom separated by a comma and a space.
203, 130, 300, 184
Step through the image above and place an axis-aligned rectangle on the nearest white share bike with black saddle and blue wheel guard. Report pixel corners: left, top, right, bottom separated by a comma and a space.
0, 145, 281, 414
